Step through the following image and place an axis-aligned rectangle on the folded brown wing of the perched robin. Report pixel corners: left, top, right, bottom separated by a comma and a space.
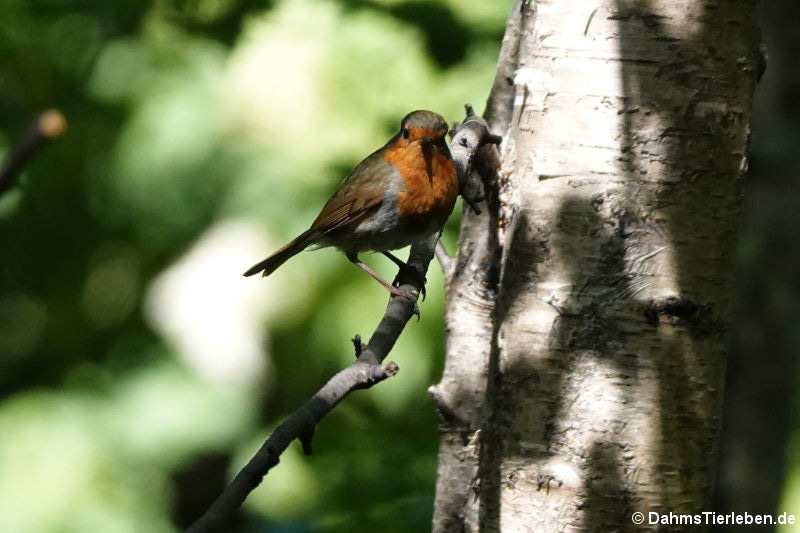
309, 149, 397, 233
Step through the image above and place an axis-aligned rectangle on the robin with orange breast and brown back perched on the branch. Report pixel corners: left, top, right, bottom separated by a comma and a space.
244, 111, 458, 296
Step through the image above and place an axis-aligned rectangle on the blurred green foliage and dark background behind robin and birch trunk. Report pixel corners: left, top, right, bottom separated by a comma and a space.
0, 0, 800, 532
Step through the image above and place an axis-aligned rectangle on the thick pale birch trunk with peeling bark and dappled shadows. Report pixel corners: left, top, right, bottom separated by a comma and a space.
432, 0, 761, 532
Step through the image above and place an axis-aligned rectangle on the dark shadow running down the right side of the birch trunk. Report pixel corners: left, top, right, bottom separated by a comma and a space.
617, 1, 777, 524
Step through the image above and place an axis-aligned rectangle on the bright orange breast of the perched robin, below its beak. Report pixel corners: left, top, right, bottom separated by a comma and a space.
383, 143, 458, 224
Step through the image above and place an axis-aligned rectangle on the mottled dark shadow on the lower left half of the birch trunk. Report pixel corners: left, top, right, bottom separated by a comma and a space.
480, 197, 644, 531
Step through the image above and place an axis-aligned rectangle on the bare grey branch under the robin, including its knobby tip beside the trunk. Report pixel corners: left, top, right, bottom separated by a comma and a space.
187, 108, 500, 533
